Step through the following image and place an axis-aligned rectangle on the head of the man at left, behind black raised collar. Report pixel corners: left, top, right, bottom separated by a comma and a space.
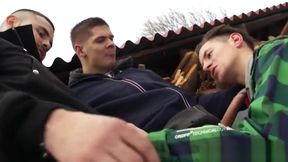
0, 9, 55, 61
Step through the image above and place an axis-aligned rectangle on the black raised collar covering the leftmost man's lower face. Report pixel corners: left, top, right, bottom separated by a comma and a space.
0, 25, 41, 62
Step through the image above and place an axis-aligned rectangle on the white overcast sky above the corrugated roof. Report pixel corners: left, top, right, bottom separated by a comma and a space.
0, 0, 287, 66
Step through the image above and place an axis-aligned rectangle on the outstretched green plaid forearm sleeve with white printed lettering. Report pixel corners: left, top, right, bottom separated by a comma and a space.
148, 121, 266, 162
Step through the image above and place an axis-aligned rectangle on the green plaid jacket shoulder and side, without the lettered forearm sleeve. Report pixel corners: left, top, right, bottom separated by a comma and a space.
250, 36, 288, 162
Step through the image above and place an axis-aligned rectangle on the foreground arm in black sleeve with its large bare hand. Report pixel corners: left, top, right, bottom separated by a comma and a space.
0, 85, 157, 162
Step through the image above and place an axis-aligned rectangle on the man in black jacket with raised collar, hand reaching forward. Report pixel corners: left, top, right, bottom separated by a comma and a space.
0, 9, 159, 162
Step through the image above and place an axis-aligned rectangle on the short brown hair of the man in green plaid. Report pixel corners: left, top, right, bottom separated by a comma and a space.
195, 24, 254, 53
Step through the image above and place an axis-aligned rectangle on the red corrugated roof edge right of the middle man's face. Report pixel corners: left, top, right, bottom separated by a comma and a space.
118, 2, 288, 55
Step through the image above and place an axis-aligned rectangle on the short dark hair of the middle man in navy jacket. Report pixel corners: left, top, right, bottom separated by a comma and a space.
71, 17, 109, 45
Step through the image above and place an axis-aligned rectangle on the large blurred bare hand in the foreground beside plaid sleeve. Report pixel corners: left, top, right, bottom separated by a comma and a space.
44, 109, 160, 162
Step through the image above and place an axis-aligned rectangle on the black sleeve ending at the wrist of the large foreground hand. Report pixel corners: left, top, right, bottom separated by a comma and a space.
0, 86, 73, 159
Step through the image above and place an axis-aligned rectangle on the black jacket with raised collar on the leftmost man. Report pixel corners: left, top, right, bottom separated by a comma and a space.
0, 26, 88, 162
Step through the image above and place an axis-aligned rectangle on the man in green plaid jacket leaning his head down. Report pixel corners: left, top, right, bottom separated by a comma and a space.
149, 25, 288, 162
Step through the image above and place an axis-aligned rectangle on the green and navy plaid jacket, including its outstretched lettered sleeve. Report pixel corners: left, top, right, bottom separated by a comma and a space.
148, 36, 288, 162
